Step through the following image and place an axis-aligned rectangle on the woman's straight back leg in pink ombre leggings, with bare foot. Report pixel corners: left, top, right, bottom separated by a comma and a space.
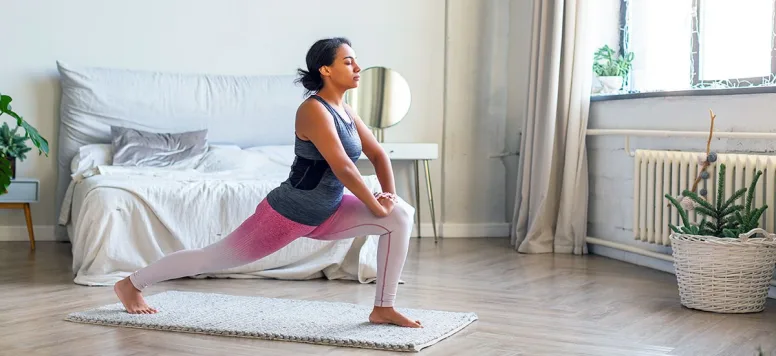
114, 200, 315, 314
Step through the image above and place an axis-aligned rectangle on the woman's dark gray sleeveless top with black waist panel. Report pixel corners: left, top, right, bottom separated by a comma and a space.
267, 95, 362, 226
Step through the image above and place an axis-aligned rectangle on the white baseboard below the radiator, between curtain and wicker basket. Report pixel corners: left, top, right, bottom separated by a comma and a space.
587, 237, 776, 299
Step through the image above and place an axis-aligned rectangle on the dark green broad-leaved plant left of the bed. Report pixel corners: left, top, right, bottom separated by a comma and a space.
0, 94, 49, 193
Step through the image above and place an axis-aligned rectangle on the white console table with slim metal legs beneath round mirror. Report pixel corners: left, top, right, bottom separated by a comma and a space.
359, 142, 439, 242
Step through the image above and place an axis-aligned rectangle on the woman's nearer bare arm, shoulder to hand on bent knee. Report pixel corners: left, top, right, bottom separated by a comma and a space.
296, 100, 390, 216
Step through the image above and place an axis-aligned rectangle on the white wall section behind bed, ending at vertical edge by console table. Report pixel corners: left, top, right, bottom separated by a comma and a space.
0, 0, 446, 240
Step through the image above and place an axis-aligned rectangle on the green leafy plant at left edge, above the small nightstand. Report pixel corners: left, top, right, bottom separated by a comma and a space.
0, 94, 49, 194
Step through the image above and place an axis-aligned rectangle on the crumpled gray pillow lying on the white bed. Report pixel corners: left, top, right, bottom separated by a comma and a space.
110, 126, 207, 169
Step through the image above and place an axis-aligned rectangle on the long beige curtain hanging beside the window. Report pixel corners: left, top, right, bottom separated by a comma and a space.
512, 0, 595, 254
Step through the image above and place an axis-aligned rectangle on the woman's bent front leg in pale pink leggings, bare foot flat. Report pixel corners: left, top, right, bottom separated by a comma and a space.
307, 194, 420, 327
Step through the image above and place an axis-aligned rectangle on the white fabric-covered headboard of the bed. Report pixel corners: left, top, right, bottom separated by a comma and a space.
56, 62, 305, 239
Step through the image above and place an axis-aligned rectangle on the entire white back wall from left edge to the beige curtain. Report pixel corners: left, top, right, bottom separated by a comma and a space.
0, 0, 532, 240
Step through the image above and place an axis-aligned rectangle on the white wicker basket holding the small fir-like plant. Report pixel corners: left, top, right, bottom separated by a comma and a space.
671, 229, 776, 313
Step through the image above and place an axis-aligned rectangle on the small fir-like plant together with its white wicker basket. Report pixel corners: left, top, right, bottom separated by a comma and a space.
665, 112, 776, 313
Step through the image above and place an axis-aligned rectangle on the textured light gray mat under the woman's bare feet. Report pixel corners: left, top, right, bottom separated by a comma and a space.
65, 291, 477, 352
